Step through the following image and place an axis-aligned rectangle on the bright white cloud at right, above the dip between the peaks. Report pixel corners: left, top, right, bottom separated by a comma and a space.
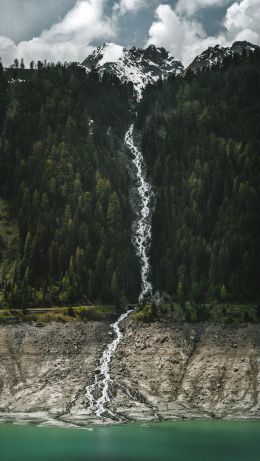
147, 0, 260, 65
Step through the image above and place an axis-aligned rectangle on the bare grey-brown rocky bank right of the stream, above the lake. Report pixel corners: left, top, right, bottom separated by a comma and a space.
109, 323, 260, 419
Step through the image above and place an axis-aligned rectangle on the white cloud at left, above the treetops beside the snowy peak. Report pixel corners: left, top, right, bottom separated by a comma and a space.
0, 0, 115, 65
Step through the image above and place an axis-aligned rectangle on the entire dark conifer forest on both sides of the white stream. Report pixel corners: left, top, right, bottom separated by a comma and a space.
0, 51, 260, 307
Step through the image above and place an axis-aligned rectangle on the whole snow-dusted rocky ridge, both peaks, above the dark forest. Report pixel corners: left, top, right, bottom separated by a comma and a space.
81, 41, 259, 99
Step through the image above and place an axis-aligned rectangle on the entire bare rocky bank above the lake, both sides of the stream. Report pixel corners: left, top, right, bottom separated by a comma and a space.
0, 320, 260, 425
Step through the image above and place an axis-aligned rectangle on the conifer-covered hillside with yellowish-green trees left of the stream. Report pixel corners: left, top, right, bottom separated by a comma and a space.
0, 63, 140, 306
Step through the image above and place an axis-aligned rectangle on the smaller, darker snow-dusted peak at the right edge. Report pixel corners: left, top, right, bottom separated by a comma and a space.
188, 41, 259, 72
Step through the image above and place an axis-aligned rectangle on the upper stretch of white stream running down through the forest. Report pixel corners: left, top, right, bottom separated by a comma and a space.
125, 124, 152, 301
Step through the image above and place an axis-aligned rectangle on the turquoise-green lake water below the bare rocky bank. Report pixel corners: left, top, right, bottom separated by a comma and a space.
0, 421, 260, 461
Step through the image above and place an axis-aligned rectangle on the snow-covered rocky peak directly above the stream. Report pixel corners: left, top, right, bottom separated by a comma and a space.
82, 43, 184, 98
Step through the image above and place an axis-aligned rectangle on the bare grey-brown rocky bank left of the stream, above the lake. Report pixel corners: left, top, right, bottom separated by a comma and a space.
0, 322, 110, 424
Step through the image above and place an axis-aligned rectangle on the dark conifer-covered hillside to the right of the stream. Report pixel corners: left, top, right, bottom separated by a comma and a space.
138, 50, 260, 302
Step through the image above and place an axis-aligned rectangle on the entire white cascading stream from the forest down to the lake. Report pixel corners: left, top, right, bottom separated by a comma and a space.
86, 124, 152, 421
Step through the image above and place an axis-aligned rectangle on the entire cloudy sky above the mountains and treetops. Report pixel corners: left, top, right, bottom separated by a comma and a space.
0, 0, 260, 65
